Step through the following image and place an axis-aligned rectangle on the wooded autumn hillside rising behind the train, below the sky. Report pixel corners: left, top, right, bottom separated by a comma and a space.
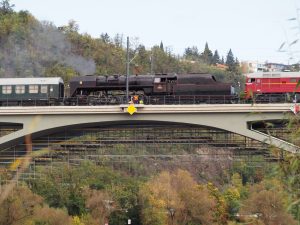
0, 0, 242, 84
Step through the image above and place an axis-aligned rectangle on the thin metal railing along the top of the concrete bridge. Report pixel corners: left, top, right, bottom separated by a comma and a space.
0, 95, 292, 107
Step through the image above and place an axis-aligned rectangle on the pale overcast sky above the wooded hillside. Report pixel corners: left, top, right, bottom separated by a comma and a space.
11, 0, 300, 64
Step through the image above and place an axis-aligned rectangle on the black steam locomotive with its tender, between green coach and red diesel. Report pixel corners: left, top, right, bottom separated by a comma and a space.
66, 73, 235, 105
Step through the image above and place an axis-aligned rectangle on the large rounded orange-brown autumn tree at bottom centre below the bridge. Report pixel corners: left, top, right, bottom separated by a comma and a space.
140, 170, 216, 225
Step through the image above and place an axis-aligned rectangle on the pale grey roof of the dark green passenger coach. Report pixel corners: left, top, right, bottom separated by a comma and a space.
0, 77, 64, 85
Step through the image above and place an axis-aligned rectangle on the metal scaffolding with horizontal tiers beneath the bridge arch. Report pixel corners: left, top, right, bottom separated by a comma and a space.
0, 123, 286, 183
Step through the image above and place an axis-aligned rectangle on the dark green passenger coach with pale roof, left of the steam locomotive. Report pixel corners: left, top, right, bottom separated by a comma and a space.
0, 77, 64, 106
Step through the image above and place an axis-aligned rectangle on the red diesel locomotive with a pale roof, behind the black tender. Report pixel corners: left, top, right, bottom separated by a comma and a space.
245, 72, 300, 102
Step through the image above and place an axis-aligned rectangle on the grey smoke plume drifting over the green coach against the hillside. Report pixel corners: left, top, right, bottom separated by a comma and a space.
0, 22, 96, 77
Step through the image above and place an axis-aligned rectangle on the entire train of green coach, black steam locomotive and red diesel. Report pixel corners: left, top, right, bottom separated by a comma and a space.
0, 72, 300, 106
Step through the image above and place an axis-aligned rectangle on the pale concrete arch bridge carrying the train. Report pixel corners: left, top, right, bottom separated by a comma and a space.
0, 103, 300, 153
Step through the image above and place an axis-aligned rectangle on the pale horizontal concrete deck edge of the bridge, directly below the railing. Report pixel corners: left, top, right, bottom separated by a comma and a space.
0, 103, 293, 116
